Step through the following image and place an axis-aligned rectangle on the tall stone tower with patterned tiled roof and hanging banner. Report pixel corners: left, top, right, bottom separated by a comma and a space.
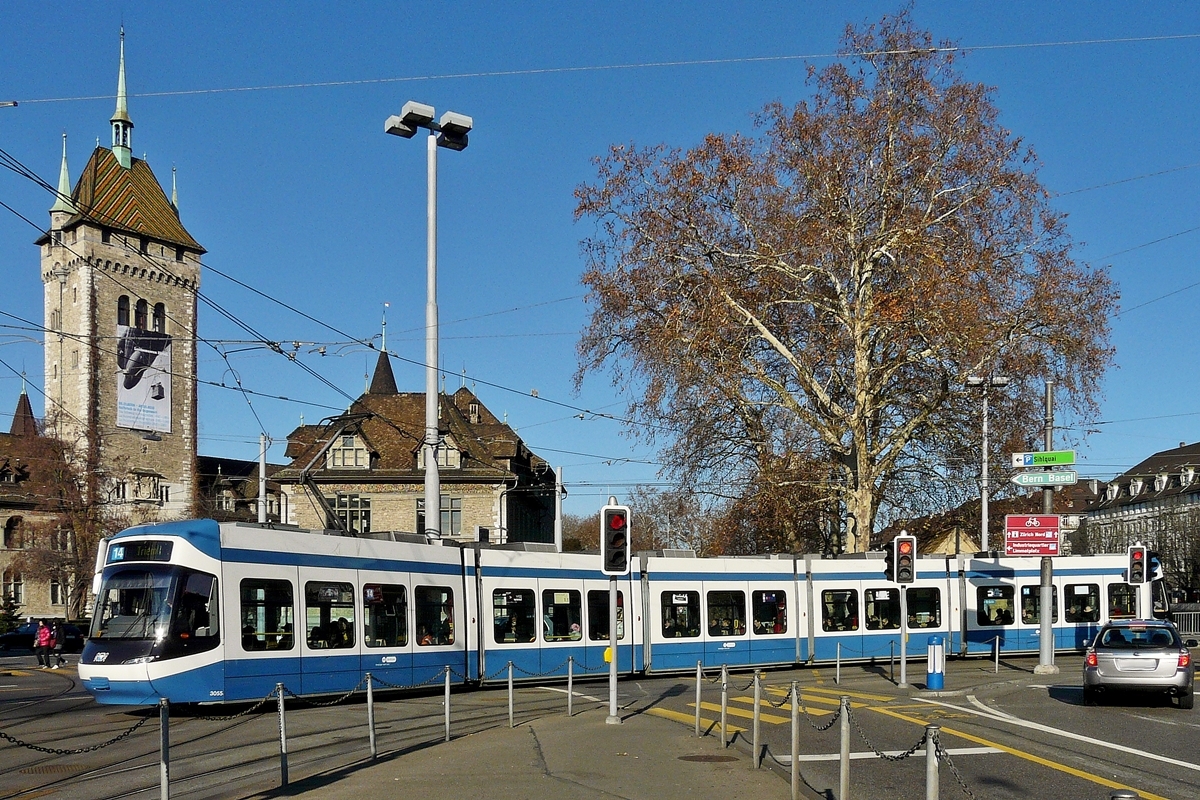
37, 30, 205, 519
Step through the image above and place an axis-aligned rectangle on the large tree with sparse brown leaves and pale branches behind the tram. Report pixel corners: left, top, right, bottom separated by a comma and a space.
576, 13, 1117, 552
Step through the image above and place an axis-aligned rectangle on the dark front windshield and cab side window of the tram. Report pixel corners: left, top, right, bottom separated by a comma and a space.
91, 565, 217, 642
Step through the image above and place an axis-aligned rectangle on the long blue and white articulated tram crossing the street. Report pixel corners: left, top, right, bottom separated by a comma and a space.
79, 521, 1166, 704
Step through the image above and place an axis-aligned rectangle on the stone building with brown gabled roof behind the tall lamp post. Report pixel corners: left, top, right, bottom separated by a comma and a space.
271, 353, 558, 543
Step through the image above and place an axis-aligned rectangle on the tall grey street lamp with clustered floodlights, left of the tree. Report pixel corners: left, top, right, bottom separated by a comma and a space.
384, 101, 473, 540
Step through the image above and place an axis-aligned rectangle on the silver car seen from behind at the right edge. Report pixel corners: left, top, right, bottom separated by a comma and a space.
1084, 619, 1196, 709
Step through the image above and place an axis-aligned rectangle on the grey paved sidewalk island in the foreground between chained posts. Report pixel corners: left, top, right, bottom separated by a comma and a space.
254, 710, 791, 800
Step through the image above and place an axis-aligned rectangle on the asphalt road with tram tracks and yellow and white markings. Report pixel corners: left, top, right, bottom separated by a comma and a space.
0, 656, 1200, 800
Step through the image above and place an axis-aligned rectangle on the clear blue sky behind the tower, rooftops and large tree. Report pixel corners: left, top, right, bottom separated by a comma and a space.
0, 1, 1200, 513
